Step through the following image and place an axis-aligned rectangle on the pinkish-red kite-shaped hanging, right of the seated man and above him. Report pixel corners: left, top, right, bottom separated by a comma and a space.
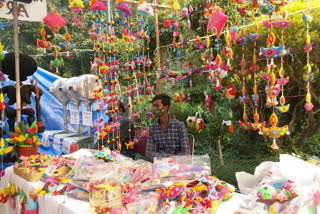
207, 7, 228, 38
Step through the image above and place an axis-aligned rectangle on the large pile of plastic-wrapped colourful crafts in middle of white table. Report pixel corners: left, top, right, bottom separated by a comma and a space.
3, 151, 234, 213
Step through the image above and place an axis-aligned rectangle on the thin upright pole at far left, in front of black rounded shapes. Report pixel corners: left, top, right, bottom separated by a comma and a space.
13, 1, 21, 123
